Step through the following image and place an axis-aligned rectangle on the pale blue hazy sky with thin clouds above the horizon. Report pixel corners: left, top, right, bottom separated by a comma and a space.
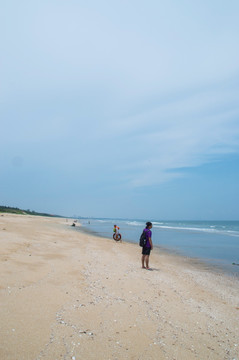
0, 0, 239, 220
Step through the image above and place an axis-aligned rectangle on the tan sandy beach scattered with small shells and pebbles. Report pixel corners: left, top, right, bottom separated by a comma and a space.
0, 214, 239, 360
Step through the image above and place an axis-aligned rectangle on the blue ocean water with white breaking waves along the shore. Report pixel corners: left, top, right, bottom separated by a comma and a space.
80, 219, 239, 275
